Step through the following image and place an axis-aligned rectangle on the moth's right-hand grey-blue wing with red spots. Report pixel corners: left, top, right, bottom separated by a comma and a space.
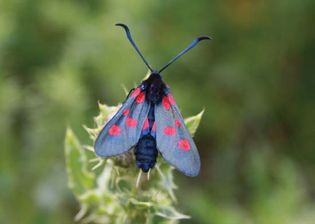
154, 94, 200, 176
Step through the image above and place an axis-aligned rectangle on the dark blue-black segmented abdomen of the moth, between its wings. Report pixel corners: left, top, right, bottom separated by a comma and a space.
135, 134, 158, 172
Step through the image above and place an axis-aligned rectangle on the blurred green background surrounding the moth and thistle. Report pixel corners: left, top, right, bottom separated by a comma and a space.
0, 0, 315, 224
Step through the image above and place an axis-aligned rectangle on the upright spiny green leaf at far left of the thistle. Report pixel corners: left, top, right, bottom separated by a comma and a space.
65, 128, 95, 197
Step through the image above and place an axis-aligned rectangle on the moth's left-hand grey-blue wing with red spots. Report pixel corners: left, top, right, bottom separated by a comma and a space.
94, 87, 150, 157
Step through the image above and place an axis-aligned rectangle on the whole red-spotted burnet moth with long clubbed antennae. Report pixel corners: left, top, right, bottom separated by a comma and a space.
94, 23, 210, 176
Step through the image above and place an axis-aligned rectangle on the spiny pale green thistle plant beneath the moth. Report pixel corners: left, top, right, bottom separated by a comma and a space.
65, 97, 203, 224
